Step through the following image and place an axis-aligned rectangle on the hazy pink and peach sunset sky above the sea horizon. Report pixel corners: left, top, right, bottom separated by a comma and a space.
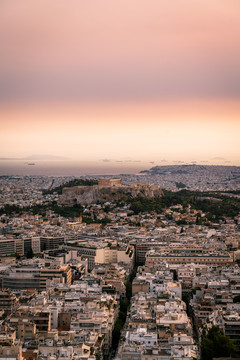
0, 0, 240, 165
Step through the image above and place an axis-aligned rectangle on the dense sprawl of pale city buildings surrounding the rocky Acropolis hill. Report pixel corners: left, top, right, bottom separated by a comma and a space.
0, 172, 240, 360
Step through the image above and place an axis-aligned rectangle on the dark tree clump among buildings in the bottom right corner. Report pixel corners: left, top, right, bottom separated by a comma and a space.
201, 326, 237, 360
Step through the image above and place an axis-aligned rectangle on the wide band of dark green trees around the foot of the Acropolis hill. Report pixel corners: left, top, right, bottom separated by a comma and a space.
0, 188, 240, 225
